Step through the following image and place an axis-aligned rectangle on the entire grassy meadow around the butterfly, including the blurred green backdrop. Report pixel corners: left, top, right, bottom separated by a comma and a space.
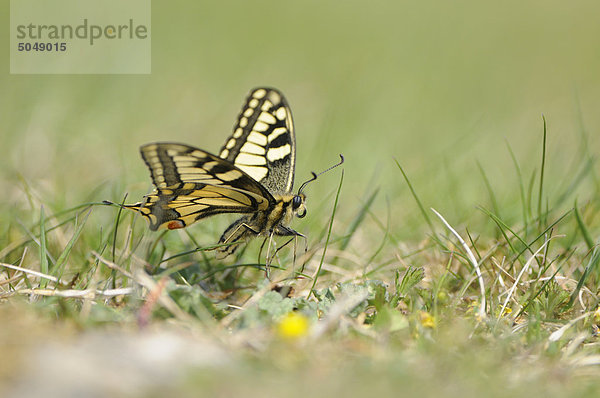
0, 0, 600, 397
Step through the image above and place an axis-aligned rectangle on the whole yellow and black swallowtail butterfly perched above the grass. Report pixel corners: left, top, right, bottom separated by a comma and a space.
108, 87, 344, 259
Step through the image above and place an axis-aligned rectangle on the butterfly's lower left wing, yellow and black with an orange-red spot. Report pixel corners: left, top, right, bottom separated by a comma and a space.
130, 142, 275, 230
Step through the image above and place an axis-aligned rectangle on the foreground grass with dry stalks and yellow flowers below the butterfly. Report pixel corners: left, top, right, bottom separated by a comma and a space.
0, 115, 600, 396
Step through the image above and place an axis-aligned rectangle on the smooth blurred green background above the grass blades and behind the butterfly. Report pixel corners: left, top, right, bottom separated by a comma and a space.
0, 0, 600, 239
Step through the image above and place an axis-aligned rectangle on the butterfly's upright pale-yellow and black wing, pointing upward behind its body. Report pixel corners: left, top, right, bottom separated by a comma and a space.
219, 87, 296, 192
